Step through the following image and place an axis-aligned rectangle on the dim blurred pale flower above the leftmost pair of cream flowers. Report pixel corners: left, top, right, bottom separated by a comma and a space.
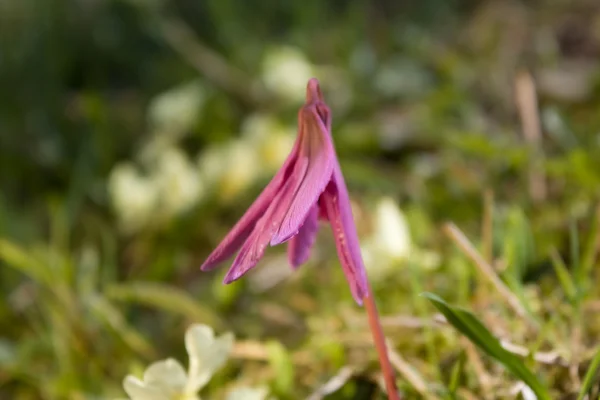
148, 81, 205, 136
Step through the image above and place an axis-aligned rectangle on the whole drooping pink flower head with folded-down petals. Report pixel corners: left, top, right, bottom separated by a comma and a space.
201, 78, 368, 304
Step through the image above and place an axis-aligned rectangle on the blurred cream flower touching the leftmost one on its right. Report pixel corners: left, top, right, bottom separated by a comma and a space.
155, 148, 204, 216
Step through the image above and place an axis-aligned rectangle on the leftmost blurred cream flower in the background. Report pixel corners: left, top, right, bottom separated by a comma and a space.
108, 163, 158, 231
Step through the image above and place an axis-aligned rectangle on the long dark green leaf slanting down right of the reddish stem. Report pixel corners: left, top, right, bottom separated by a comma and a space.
422, 293, 551, 400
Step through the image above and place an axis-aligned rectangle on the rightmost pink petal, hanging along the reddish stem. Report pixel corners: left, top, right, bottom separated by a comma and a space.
320, 163, 368, 304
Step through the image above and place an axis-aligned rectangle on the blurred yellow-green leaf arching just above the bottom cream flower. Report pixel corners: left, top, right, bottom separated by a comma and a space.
105, 282, 222, 326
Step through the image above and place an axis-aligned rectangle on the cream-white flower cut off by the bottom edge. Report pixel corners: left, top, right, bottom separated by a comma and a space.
123, 324, 234, 400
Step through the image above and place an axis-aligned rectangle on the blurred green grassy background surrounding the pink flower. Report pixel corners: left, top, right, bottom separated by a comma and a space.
0, 0, 600, 399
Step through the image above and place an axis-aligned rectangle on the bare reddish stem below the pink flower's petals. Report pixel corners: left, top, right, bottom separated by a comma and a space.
363, 284, 400, 400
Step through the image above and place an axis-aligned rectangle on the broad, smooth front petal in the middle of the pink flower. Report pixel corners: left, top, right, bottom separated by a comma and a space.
271, 102, 335, 246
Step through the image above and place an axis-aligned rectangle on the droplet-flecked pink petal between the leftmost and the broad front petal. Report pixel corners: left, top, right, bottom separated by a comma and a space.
223, 159, 308, 283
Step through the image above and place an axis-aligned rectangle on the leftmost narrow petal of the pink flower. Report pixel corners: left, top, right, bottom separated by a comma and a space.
200, 139, 300, 271
